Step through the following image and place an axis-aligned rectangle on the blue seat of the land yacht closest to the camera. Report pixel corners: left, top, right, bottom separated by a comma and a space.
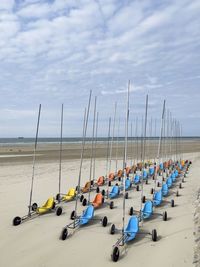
124, 216, 139, 242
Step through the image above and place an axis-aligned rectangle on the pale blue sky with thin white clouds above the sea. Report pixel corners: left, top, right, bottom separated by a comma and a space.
0, 0, 200, 137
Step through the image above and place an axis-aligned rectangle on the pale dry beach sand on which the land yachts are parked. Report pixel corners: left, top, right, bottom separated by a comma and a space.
0, 144, 200, 267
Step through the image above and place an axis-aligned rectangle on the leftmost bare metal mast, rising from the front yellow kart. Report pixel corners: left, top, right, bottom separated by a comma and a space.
28, 104, 41, 216
